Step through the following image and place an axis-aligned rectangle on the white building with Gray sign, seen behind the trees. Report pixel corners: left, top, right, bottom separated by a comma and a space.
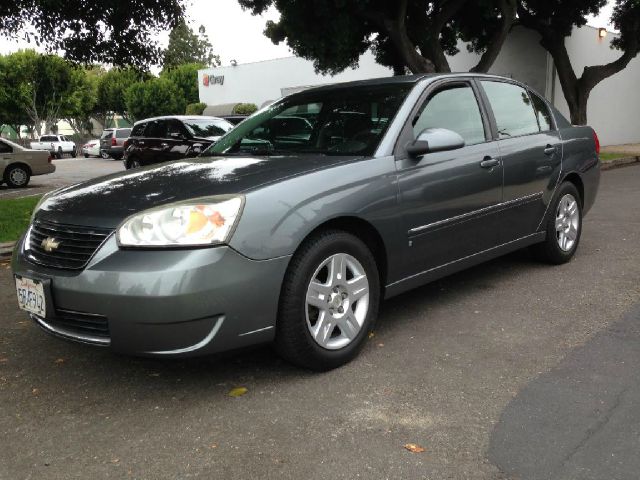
198, 27, 640, 145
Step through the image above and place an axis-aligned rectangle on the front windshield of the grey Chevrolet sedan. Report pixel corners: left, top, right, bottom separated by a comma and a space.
205, 84, 412, 155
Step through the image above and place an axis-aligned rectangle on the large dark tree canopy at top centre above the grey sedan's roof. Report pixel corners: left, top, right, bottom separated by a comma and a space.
239, 0, 516, 74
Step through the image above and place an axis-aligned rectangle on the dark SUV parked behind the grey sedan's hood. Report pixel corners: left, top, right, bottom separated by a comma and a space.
124, 116, 233, 169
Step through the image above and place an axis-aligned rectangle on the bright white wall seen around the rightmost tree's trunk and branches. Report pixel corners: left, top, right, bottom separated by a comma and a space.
554, 27, 640, 145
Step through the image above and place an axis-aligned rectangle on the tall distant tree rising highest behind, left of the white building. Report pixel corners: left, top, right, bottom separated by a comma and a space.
162, 20, 220, 71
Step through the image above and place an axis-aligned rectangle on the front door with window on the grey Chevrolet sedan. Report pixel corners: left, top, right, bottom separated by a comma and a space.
396, 80, 502, 274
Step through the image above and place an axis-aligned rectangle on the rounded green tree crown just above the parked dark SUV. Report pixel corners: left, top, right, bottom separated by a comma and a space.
124, 77, 186, 120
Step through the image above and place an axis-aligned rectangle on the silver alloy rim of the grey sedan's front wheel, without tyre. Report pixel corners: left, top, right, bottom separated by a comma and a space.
306, 253, 369, 350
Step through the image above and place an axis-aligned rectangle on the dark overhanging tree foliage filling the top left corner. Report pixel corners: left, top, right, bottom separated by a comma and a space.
0, 0, 184, 69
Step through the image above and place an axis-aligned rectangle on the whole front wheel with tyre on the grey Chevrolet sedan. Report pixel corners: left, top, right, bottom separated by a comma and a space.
276, 230, 380, 371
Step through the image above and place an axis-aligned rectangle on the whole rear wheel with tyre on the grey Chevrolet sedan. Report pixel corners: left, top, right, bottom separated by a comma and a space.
533, 182, 582, 265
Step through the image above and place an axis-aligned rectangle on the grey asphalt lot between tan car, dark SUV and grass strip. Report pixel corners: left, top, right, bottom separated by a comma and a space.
0, 157, 124, 199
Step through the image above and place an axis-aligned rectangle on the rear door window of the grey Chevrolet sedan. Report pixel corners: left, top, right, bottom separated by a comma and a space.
480, 80, 540, 139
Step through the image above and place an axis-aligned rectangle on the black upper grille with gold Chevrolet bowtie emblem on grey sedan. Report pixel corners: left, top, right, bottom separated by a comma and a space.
26, 220, 113, 270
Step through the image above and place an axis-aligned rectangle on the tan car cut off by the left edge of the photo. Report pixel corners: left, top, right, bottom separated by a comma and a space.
0, 138, 56, 188
